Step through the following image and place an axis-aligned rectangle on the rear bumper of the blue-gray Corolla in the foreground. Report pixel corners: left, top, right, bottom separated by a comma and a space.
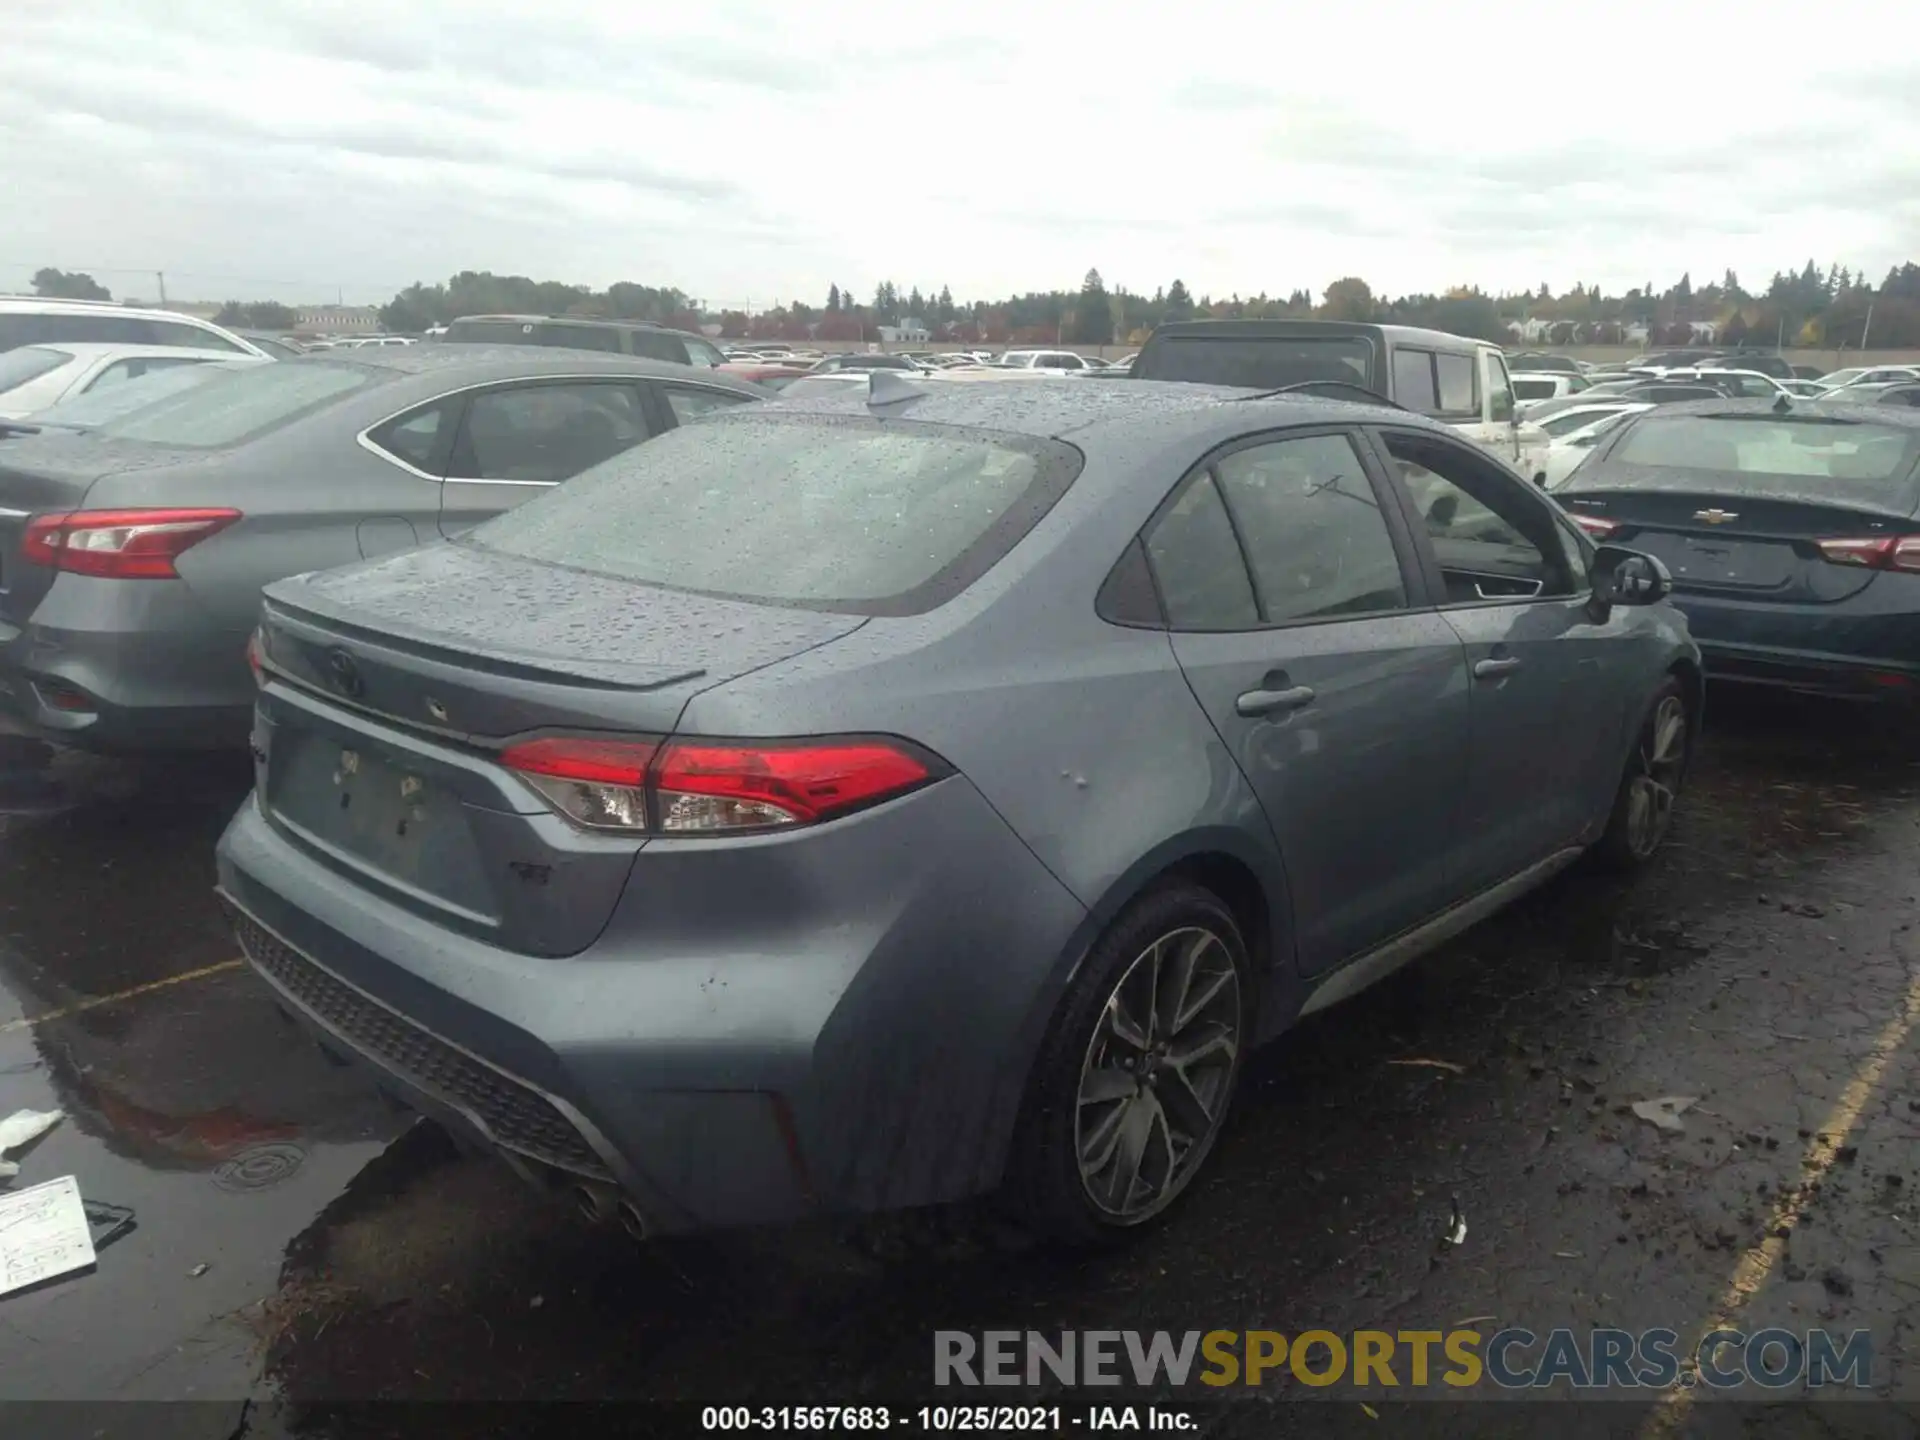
219, 778, 1085, 1231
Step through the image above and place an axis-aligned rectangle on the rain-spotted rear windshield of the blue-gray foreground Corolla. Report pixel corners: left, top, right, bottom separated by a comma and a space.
467, 413, 1081, 614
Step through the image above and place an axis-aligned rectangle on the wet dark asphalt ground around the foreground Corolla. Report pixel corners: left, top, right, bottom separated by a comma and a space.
0, 693, 1920, 1434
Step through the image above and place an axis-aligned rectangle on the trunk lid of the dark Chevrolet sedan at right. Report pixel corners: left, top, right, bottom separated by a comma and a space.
1561, 484, 1920, 605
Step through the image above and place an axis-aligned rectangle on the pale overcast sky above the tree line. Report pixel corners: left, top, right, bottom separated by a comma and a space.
0, 0, 1920, 307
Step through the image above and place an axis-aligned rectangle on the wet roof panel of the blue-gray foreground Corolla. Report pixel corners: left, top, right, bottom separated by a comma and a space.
748, 376, 1455, 449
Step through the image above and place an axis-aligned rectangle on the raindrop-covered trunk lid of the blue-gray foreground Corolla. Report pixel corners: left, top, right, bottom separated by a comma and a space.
255, 543, 862, 956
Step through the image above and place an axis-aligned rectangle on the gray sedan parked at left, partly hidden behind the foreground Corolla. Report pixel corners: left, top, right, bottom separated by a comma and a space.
0, 346, 766, 751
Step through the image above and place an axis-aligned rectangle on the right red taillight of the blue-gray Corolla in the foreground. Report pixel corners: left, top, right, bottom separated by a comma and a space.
499, 737, 939, 835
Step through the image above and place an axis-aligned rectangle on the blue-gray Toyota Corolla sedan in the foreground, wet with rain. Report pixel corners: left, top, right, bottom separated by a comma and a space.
219, 376, 1701, 1238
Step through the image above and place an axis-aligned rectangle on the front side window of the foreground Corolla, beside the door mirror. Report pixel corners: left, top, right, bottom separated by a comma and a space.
1386, 432, 1572, 605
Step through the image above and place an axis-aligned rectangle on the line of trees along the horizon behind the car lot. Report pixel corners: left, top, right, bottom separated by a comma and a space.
33, 259, 1920, 349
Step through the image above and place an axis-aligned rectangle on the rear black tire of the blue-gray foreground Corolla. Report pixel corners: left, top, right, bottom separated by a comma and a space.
1006, 881, 1256, 1246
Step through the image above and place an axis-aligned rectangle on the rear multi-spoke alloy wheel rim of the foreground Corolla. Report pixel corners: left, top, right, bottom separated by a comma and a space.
1073, 925, 1242, 1225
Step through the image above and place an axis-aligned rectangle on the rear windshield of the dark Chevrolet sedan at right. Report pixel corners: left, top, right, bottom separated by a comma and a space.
1607, 415, 1920, 513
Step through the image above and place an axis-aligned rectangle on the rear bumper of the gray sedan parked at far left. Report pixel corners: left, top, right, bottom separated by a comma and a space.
0, 602, 253, 753
